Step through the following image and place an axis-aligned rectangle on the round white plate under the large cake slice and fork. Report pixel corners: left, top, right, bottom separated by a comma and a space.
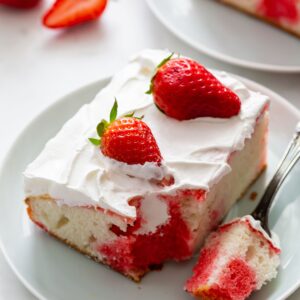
0, 75, 300, 300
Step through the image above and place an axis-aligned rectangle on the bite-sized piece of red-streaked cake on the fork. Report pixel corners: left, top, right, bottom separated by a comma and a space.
185, 215, 280, 300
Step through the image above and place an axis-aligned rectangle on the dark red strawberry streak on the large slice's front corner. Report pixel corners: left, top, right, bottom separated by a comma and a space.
98, 191, 204, 272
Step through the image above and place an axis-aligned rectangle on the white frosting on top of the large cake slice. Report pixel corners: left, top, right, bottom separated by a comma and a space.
24, 50, 268, 218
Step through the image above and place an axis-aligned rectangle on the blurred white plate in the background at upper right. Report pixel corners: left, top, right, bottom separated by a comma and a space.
147, 0, 300, 72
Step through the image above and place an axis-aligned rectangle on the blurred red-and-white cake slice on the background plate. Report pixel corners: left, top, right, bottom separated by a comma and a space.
219, 0, 300, 36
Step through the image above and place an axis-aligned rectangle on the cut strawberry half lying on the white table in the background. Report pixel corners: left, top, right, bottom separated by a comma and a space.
42, 0, 107, 28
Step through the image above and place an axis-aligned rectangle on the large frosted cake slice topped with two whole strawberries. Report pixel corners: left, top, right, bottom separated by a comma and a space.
24, 50, 269, 281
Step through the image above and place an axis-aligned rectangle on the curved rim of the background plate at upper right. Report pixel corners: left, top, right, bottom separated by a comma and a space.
146, 0, 300, 74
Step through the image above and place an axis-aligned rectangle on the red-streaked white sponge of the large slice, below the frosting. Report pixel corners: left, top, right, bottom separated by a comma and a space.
26, 109, 268, 281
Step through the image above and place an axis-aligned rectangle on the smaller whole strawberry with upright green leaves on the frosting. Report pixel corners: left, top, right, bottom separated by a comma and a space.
89, 101, 162, 165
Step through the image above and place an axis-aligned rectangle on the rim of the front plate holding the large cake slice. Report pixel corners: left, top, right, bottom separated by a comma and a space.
0, 72, 300, 300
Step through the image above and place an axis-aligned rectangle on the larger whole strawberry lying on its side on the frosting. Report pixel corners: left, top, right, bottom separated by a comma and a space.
147, 56, 241, 120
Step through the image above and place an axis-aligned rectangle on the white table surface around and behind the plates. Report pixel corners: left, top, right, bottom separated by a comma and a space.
0, 0, 300, 300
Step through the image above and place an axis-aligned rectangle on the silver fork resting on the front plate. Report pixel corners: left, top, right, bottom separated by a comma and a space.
251, 122, 300, 236
